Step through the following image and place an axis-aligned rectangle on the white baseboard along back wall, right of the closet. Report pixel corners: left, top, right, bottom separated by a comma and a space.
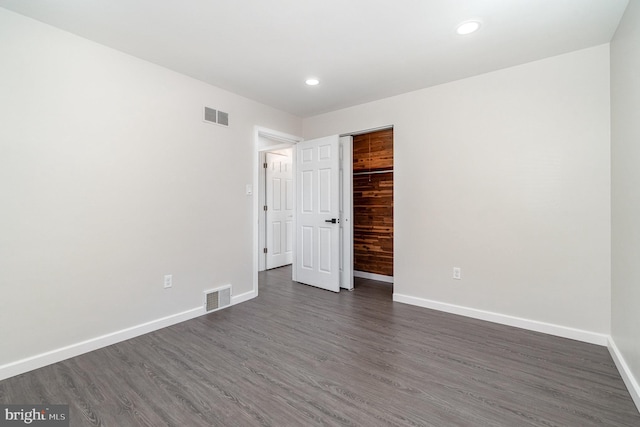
393, 293, 609, 346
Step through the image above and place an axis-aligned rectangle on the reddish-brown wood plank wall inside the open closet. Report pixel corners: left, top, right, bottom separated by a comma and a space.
353, 129, 393, 281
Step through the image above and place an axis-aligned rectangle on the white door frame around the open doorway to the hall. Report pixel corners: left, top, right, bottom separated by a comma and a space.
252, 126, 303, 297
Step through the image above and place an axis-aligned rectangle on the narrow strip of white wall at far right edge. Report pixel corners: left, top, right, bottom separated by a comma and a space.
611, 1, 640, 407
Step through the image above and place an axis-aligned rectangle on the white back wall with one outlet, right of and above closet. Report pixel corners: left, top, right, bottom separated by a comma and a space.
303, 45, 611, 344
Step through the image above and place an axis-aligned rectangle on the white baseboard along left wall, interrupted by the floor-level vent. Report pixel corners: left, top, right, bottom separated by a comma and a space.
0, 291, 255, 381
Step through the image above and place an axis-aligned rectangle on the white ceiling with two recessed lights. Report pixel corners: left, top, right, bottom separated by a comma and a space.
0, 0, 628, 117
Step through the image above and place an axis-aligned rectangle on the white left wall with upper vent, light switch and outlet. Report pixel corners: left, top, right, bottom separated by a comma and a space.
0, 9, 301, 367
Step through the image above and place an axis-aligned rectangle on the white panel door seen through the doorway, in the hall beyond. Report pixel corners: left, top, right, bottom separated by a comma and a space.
265, 149, 294, 269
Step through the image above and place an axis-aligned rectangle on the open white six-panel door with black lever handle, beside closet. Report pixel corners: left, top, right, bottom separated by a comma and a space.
294, 135, 341, 292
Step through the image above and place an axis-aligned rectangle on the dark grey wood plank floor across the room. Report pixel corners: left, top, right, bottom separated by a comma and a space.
0, 267, 640, 427
